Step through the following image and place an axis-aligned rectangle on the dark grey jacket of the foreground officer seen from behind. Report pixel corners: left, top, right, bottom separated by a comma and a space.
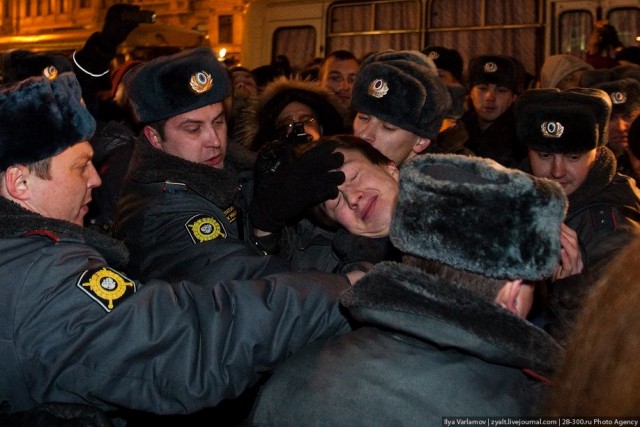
252, 262, 561, 427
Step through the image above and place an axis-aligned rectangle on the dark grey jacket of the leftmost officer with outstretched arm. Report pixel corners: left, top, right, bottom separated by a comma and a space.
0, 198, 348, 414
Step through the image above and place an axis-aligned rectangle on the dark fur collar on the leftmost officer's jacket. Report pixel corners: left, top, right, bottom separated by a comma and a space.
0, 197, 129, 268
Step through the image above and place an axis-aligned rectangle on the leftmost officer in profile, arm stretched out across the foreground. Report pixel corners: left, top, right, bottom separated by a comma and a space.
0, 73, 349, 424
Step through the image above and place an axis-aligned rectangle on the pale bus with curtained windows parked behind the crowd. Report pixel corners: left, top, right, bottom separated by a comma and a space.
242, 0, 640, 75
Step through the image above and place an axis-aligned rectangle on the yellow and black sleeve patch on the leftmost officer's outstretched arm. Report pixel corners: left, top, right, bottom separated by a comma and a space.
77, 267, 136, 312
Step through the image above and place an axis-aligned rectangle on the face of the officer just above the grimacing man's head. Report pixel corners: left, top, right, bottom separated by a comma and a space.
353, 113, 430, 165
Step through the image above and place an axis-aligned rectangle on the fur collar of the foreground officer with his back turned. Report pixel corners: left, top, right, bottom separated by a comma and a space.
341, 262, 562, 374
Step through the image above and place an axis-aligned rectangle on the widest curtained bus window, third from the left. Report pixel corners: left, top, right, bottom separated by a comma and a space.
425, 0, 543, 74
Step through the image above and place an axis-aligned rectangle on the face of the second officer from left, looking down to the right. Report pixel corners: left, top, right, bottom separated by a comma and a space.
145, 102, 227, 169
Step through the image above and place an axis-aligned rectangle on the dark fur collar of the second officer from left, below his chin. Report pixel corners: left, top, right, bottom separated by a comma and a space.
127, 137, 240, 207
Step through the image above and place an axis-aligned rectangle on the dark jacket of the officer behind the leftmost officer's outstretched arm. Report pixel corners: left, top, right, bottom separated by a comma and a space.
114, 138, 289, 280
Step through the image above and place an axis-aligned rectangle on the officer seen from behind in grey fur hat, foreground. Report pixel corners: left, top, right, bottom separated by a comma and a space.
252, 154, 567, 426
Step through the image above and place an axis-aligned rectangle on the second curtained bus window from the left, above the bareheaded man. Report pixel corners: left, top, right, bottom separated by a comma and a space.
326, 0, 421, 57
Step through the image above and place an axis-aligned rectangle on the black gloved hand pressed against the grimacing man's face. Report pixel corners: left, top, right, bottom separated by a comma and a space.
249, 143, 344, 232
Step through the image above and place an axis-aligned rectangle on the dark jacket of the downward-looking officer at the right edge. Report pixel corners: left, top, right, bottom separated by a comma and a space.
523, 147, 640, 343
